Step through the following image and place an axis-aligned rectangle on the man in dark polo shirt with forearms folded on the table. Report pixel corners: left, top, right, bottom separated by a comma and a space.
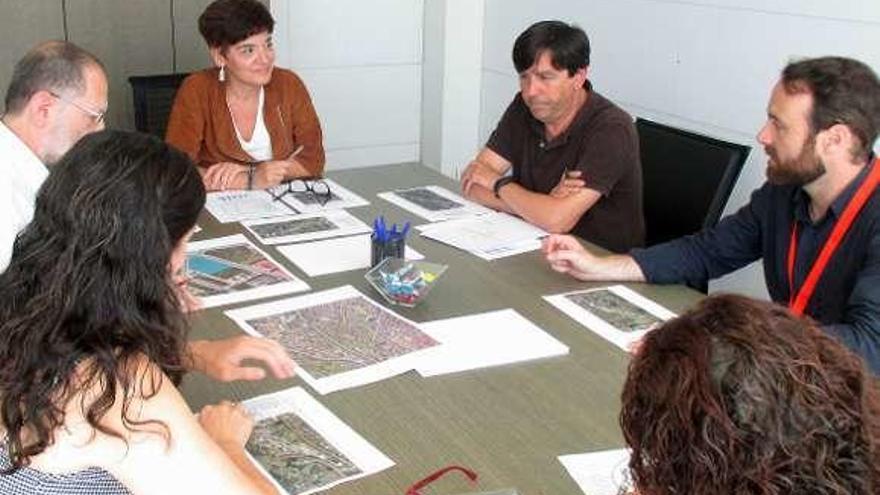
461, 21, 645, 252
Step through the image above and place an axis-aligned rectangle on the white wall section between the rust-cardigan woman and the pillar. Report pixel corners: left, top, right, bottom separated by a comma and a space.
271, 0, 423, 170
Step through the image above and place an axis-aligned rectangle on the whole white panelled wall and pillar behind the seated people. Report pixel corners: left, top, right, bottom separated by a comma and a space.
271, 0, 880, 296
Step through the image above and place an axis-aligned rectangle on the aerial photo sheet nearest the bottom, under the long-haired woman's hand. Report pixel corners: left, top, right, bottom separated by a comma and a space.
242, 387, 394, 495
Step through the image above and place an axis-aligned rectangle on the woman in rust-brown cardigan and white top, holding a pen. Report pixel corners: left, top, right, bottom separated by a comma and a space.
165, 0, 324, 190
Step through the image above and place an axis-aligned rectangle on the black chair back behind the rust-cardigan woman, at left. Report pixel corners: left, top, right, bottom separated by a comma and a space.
128, 74, 189, 139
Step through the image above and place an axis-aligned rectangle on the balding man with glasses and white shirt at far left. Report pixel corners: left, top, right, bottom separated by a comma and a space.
0, 41, 107, 271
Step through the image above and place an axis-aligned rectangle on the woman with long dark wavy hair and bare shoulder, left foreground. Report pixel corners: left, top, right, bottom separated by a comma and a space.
0, 131, 274, 494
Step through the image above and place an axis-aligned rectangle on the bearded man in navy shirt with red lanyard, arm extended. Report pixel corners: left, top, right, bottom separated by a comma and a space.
544, 57, 880, 374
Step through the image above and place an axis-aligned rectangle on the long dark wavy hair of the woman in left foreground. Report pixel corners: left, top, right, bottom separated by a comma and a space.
0, 131, 205, 470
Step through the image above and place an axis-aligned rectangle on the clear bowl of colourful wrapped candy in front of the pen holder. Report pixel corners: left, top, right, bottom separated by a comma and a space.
364, 258, 446, 308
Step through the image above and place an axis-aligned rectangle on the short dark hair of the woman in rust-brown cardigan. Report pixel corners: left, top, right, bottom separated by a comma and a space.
199, 0, 275, 50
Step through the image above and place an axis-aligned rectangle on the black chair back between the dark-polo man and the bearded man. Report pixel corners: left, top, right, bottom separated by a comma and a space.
636, 118, 751, 246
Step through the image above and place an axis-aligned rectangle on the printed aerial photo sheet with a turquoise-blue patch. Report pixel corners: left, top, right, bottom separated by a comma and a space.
186, 234, 309, 308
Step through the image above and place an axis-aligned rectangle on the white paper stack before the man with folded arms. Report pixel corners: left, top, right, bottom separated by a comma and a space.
416, 212, 547, 260
